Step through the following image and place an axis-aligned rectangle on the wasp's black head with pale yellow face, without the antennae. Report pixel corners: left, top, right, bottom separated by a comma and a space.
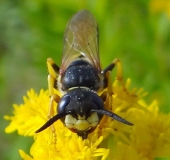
58, 88, 104, 138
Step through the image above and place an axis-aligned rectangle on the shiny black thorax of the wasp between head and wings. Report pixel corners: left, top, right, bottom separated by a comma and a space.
61, 60, 100, 91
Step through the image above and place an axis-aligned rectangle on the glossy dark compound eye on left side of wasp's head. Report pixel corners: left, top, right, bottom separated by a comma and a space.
57, 95, 70, 114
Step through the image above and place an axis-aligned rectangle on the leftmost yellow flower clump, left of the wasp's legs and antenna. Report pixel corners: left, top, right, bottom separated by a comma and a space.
5, 89, 49, 136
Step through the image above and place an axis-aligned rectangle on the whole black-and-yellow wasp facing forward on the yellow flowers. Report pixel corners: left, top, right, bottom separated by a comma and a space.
36, 10, 133, 139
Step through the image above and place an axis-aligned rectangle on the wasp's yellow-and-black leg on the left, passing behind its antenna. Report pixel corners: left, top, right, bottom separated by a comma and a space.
47, 58, 60, 142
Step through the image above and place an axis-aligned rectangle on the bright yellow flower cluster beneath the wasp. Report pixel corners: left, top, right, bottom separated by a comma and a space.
5, 79, 170, 160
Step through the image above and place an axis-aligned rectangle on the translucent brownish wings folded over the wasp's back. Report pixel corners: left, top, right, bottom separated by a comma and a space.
60, 10, 101, 74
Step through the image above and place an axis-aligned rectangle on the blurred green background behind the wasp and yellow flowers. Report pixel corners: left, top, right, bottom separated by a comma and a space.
0, 0, 170, 160
